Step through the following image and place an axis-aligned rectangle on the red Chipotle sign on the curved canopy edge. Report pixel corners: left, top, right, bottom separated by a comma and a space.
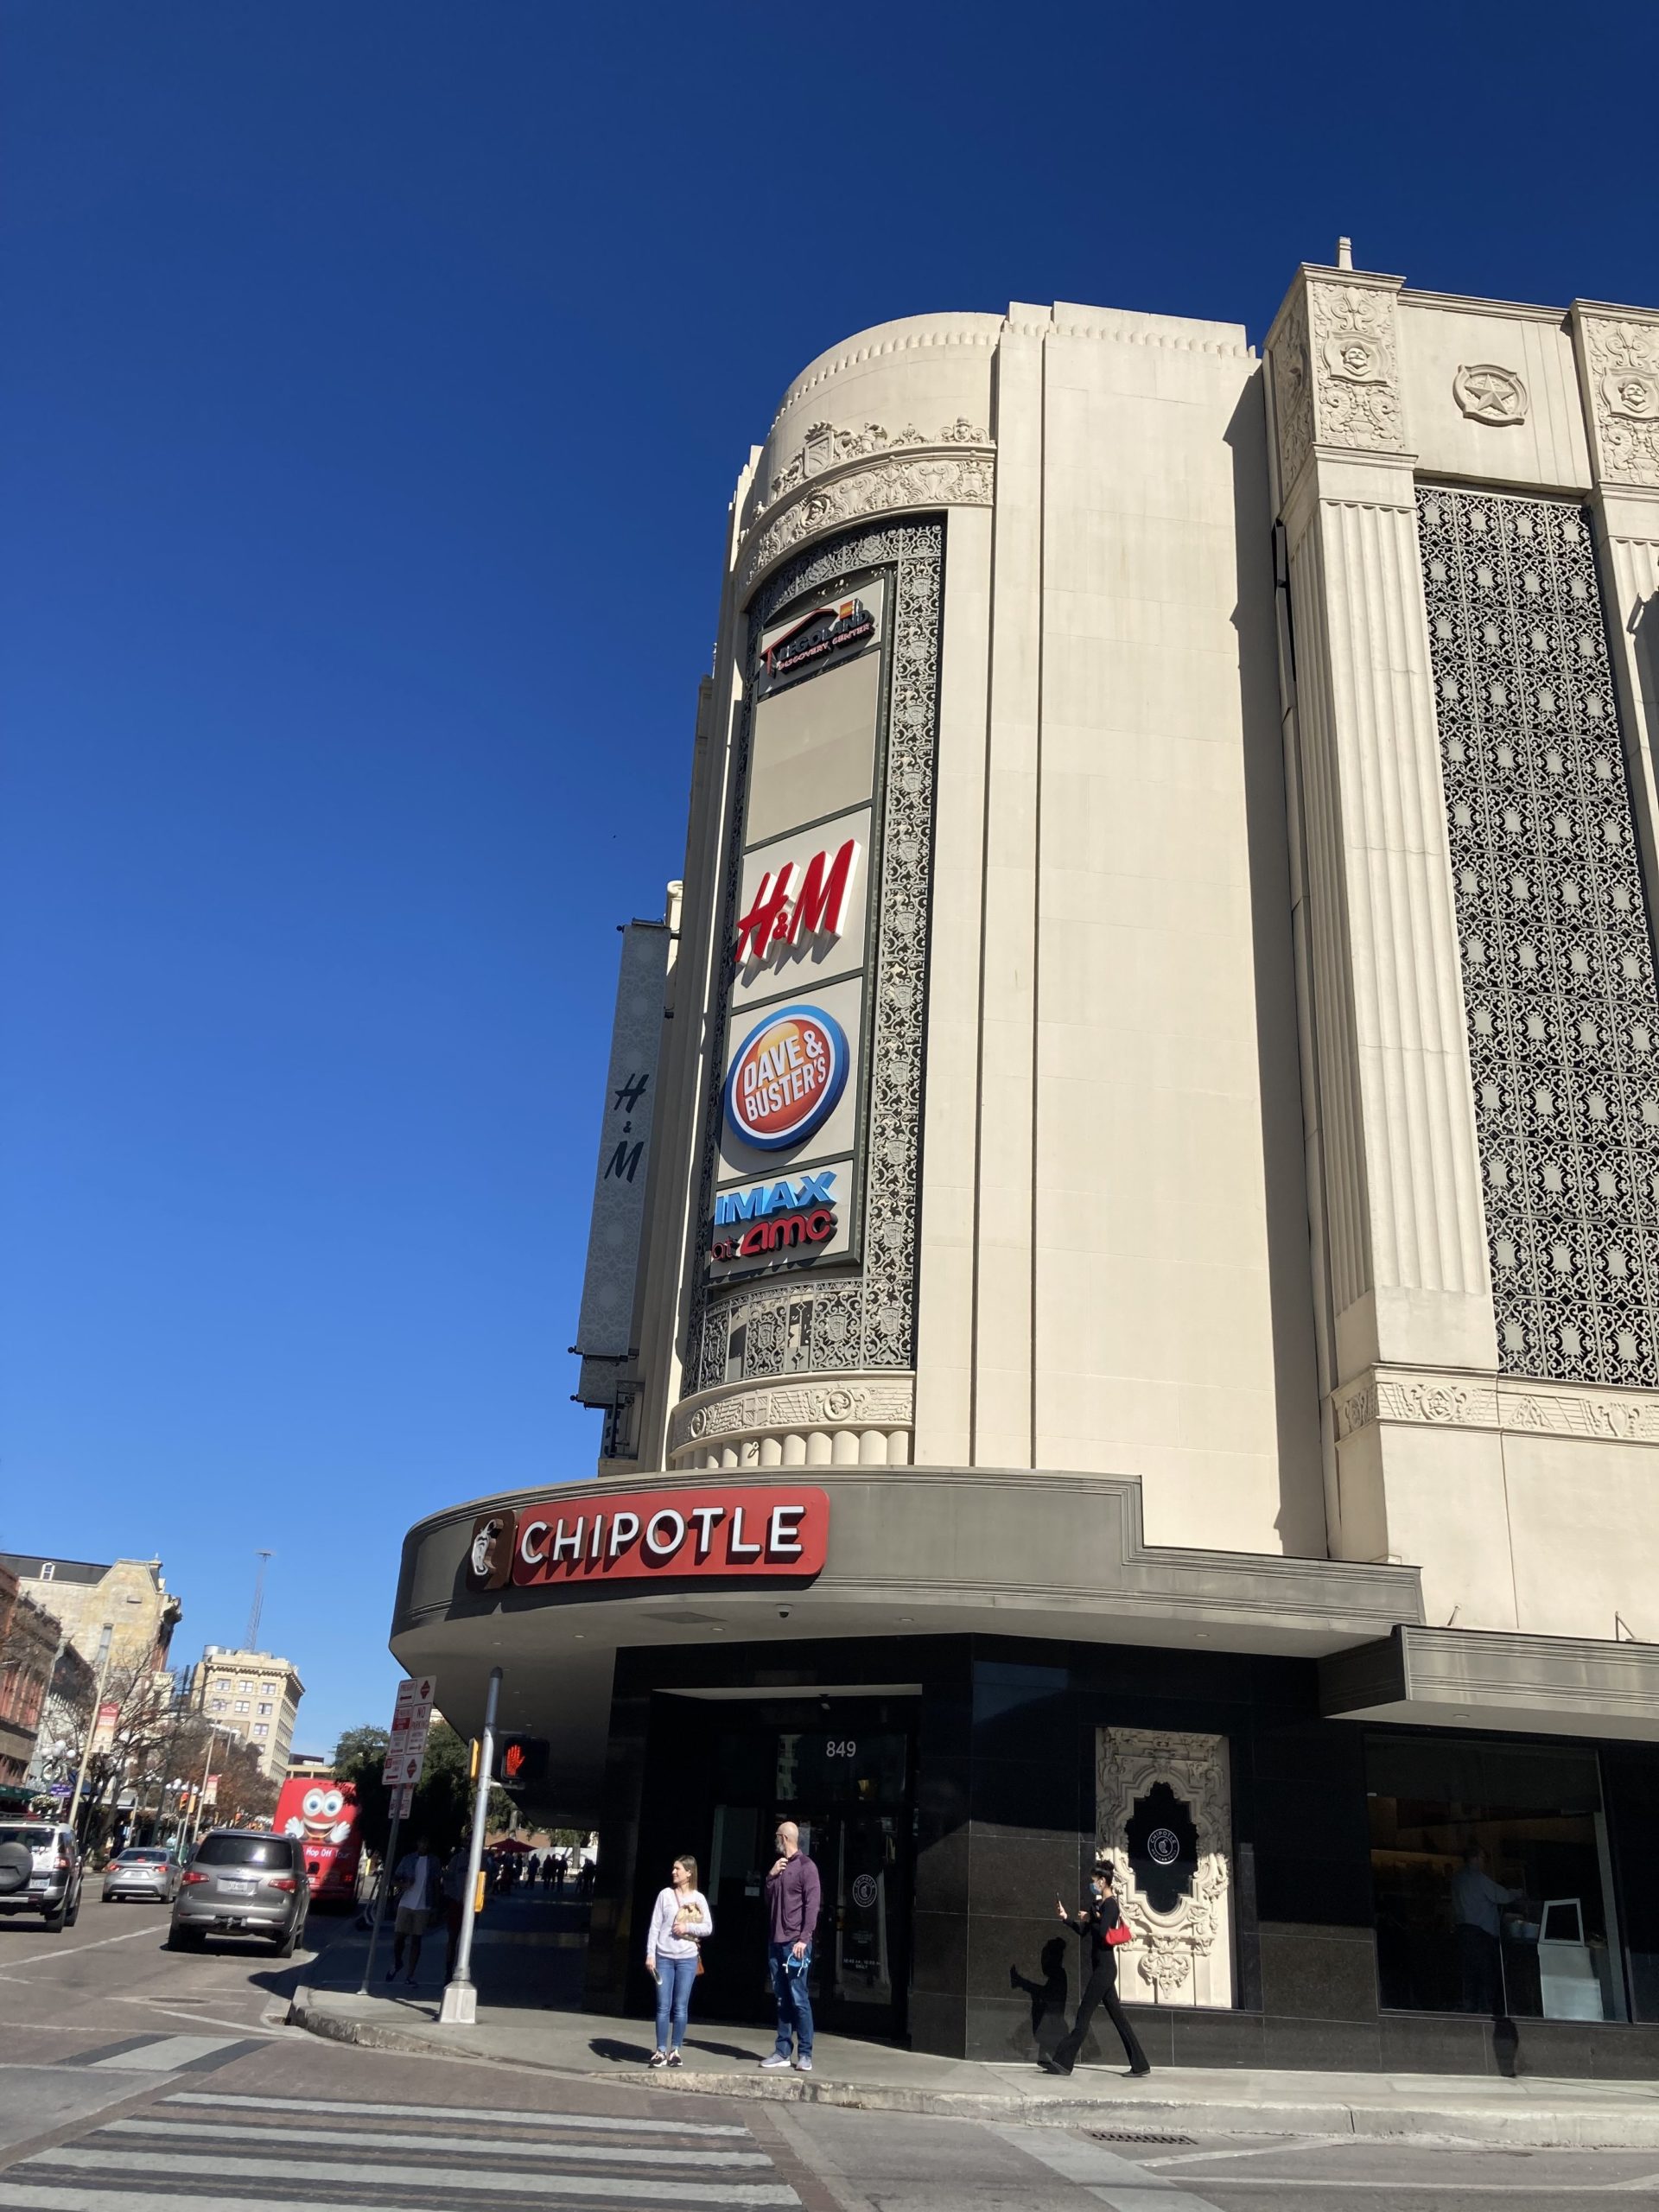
467, 1486, 830, 1591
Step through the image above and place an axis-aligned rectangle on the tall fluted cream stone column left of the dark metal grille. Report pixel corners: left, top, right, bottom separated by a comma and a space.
1268, 268, 1497, 1557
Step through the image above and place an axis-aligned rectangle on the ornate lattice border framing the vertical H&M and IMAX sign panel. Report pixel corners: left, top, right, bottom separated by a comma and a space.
683, 518, 944, 1397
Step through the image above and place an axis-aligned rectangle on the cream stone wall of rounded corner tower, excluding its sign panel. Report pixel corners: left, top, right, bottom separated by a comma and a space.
619, 308, 1325, 1555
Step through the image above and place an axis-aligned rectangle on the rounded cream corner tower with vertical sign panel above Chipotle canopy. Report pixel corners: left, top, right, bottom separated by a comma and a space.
631, 294, 1325, 1553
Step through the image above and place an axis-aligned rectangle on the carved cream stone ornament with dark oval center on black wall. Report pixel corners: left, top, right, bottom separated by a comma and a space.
1095, 1727, 1232, 2006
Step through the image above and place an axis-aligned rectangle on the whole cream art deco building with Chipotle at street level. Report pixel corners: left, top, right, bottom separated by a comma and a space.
394, 254, 1659, 2073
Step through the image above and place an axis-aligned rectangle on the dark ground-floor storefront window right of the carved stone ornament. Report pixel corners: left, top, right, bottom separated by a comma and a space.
1365, 1737, 1628, 2019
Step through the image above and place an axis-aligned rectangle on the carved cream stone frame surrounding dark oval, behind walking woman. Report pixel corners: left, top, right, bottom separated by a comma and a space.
1095, 1727, 1234, 2006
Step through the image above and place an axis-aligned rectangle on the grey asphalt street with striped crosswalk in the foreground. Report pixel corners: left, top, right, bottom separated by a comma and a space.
0, 1897, 1659, 2212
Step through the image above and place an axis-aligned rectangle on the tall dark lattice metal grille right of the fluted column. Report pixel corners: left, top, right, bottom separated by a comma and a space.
1418, 485, 1659, 1387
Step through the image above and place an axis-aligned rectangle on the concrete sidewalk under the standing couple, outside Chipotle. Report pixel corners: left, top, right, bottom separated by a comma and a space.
288, 1988, 1659, 2150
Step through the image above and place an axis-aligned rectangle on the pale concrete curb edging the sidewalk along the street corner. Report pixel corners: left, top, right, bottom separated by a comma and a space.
288, 1991, 1659, 2150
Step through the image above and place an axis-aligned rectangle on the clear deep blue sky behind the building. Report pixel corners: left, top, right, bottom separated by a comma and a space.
0, 0, 1659, 1747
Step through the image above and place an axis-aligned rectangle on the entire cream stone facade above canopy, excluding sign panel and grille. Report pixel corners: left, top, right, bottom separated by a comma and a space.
604, 270, 1659, 1663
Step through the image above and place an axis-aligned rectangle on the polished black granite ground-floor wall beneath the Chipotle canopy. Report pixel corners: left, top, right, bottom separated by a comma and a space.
586, 1637, 1659, 2077
